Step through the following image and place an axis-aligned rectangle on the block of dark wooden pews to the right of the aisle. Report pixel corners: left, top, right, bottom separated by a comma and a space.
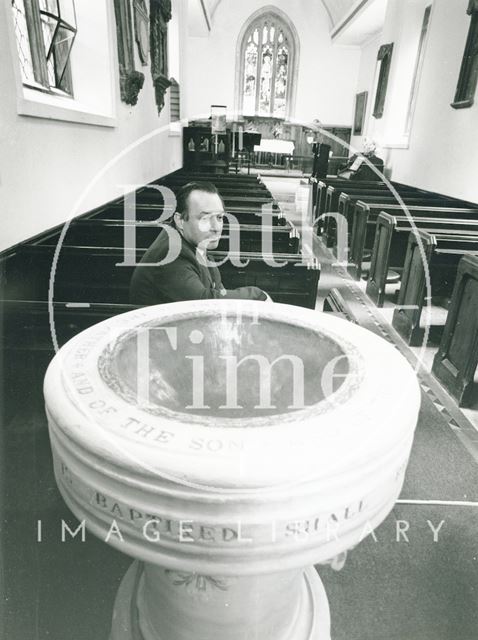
314, 178, 478, 406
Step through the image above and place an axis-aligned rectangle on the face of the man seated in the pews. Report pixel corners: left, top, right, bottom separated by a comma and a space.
176, 191, 224, 250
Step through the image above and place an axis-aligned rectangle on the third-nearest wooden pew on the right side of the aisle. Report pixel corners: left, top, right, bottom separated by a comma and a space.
366, 212, 478, 307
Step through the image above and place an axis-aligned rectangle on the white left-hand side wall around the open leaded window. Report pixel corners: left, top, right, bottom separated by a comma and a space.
0, 0, 185, 250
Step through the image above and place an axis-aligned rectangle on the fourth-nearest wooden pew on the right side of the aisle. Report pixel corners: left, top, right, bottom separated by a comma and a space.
347, 200, 478, 280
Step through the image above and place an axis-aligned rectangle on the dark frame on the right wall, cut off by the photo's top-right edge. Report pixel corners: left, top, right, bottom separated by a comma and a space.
451, 0, 478, 109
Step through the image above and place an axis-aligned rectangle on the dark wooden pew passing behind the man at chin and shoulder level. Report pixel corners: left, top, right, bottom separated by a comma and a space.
38, 219, 300, 253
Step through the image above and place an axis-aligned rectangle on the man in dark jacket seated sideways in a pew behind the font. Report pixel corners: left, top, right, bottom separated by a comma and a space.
130, 182, 270, 306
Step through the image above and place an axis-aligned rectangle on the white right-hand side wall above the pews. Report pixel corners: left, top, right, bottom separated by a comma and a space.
355, 0, 478, 202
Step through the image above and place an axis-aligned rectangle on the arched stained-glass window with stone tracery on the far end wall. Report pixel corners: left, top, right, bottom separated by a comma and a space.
238, 12, 297, 118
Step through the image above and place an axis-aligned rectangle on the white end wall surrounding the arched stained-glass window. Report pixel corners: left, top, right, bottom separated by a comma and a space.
187, 0, 360, 126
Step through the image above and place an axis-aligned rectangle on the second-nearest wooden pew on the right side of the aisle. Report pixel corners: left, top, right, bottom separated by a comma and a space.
392, 230, 478, 346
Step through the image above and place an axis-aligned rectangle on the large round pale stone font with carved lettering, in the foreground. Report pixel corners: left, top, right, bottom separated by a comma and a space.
44, 301, 420, 640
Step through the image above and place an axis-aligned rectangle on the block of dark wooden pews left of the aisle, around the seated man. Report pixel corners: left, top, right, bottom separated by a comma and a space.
0, 171, 320, 380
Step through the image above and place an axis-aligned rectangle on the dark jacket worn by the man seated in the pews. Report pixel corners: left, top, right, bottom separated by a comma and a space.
130, 225, 266, 306
